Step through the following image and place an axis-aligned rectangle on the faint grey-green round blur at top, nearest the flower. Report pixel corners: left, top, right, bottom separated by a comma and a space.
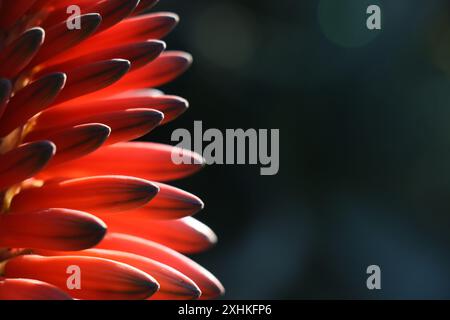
193, 3, 257, 68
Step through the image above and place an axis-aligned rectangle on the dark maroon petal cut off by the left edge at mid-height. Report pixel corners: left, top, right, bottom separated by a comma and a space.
0, 141, 56, 190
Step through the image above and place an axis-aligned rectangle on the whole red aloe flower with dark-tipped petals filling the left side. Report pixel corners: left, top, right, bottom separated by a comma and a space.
0, 0, 224, 299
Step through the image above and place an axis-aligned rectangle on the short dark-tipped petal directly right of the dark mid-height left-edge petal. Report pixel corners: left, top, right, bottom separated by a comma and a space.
48, 123, 111, 166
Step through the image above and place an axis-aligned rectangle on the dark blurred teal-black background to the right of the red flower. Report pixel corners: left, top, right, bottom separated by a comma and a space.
148, 0, 450, 299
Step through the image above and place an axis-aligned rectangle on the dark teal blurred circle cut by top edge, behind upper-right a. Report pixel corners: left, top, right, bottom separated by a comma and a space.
318, 0, 385, 48
